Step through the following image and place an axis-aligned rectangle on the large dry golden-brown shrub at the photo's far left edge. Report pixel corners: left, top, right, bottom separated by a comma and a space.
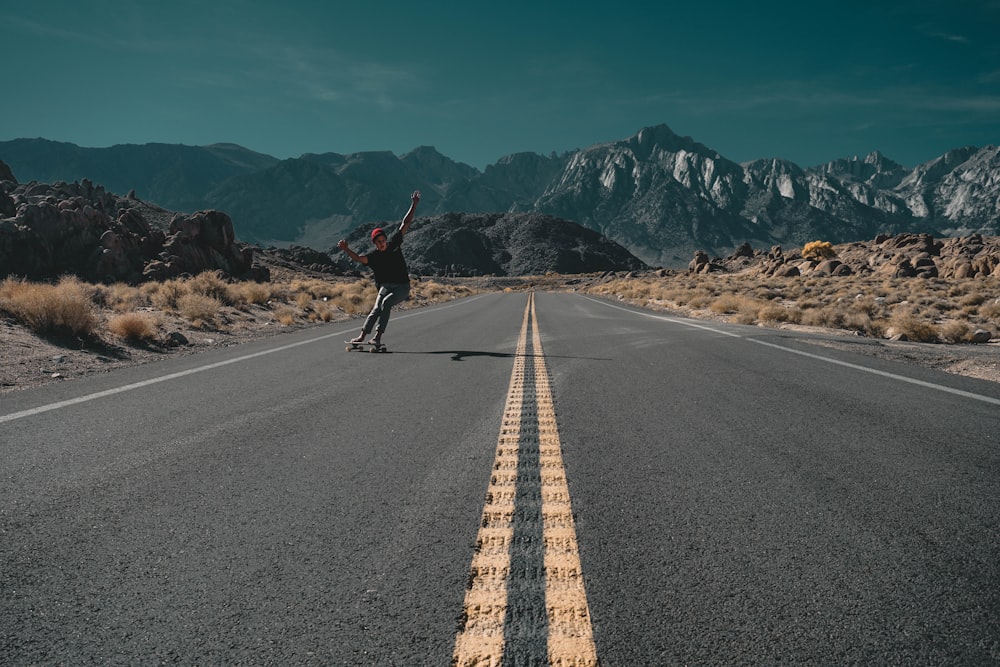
0, 277, 97, 336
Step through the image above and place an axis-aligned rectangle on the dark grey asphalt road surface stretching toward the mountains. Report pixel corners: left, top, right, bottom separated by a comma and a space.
0, 293, 1000, 667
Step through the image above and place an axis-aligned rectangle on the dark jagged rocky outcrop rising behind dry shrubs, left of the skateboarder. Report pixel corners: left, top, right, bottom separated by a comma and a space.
0, 170, 266, 283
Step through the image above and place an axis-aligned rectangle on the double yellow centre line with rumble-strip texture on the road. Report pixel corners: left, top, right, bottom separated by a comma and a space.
452, 293, 598, 667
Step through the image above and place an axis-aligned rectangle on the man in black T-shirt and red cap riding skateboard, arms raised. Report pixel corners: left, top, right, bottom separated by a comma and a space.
337, 190, 420, 348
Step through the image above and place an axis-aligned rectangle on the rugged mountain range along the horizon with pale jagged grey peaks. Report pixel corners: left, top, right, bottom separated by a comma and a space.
0, 125, 1000, 266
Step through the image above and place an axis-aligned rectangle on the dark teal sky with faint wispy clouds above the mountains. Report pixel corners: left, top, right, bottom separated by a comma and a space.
0, 0, 1000, 168
